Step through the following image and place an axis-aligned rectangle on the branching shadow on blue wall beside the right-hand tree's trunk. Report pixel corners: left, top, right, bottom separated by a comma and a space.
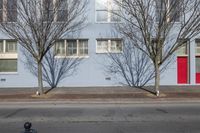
105, 40, 154, 88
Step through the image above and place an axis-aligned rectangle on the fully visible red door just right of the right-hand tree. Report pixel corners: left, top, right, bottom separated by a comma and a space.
177, 57, 188, 84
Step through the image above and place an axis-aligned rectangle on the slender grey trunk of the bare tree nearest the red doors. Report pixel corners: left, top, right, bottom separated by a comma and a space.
154, 62, 160, 96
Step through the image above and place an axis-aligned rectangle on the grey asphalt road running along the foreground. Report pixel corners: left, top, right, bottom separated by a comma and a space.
0, 103, 200, 133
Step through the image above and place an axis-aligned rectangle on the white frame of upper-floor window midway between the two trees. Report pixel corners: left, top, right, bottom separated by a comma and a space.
95, 0, 121, 23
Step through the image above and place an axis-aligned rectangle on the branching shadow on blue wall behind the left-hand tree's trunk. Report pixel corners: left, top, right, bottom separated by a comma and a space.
23, 49, 83, 92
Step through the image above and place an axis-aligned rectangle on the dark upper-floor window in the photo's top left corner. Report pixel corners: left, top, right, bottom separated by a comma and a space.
0, 0, 17, 22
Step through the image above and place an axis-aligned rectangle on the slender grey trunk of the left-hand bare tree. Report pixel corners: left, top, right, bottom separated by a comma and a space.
38, 61, 43, 95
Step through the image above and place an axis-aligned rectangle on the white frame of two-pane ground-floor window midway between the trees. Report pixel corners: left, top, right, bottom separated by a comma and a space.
96, 39, 123, 54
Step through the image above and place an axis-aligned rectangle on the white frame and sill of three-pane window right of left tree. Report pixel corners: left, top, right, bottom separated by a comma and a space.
55, 39, 89, 58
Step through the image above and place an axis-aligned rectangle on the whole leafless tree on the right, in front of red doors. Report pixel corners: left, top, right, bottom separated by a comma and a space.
113, 0, 200, 96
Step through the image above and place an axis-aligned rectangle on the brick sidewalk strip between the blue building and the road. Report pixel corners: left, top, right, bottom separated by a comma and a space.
0, 86, 200, 103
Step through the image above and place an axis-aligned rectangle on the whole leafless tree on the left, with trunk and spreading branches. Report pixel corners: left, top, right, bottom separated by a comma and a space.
1, 0, 87, 94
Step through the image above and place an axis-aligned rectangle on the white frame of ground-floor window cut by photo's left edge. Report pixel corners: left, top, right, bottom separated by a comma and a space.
0, 39, 18, 74
